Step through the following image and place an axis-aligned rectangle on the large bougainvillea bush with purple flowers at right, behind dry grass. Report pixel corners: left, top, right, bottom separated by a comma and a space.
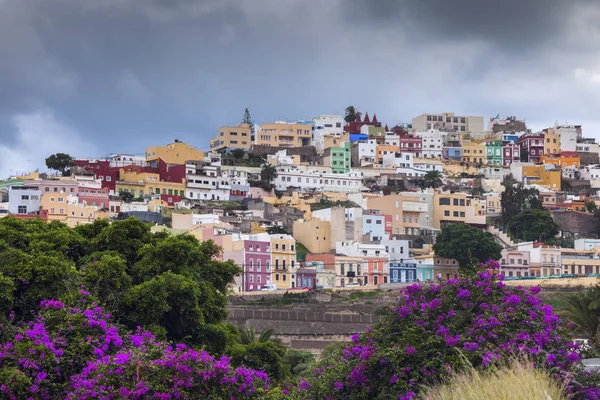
280, 262, 579, 399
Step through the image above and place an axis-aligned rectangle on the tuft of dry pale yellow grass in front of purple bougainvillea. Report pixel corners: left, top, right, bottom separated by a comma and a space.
422, 362, 567, 400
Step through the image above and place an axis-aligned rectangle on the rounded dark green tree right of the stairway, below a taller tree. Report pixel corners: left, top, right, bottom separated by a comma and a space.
506, 210, 558, 241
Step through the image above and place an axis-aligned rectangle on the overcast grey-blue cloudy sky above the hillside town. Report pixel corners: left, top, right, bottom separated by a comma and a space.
0, 0, 600, 177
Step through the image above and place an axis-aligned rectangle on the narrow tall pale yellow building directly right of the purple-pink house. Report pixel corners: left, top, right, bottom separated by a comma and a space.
271, 234, 296, 289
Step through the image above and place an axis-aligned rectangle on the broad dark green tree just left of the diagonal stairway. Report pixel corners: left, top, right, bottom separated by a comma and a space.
433, 224, 502, 271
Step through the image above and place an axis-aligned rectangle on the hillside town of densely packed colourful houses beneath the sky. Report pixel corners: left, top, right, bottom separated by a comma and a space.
0, 110, 600, 293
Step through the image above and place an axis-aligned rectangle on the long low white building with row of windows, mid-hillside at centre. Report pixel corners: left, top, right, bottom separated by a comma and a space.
274, 165, 364, 193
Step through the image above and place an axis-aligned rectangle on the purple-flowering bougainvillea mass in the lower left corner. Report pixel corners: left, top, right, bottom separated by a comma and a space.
0, 300, 269, 399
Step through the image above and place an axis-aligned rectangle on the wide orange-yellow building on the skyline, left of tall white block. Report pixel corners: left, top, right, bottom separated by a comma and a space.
254, 122, 312, 147
